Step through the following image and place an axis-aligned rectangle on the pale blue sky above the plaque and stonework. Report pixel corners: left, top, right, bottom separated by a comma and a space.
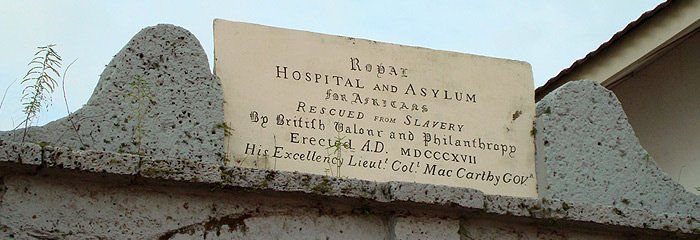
0, 0, 662, 131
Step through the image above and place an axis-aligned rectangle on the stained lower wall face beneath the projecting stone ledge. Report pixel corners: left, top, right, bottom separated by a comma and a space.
0, 165, 680, 239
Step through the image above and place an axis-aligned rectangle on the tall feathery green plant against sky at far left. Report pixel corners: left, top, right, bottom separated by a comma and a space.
17, 44, 61, 142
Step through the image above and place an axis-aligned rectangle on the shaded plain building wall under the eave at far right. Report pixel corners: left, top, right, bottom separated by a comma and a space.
610, 32, 700, 194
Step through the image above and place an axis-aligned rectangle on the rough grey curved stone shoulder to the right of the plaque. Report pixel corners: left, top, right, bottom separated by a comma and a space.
536, 81, 700, 218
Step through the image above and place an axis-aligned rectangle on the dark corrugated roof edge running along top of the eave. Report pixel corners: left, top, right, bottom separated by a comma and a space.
535, 0, 674, 101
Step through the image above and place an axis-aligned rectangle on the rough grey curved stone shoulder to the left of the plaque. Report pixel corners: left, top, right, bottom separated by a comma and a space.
0, 24, 224, 162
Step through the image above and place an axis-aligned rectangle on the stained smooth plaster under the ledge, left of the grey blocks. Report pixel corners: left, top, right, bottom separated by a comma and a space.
0, 175, 388, 239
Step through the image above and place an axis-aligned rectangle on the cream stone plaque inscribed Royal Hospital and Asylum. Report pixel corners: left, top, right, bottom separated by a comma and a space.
214, 19, 537, 197
